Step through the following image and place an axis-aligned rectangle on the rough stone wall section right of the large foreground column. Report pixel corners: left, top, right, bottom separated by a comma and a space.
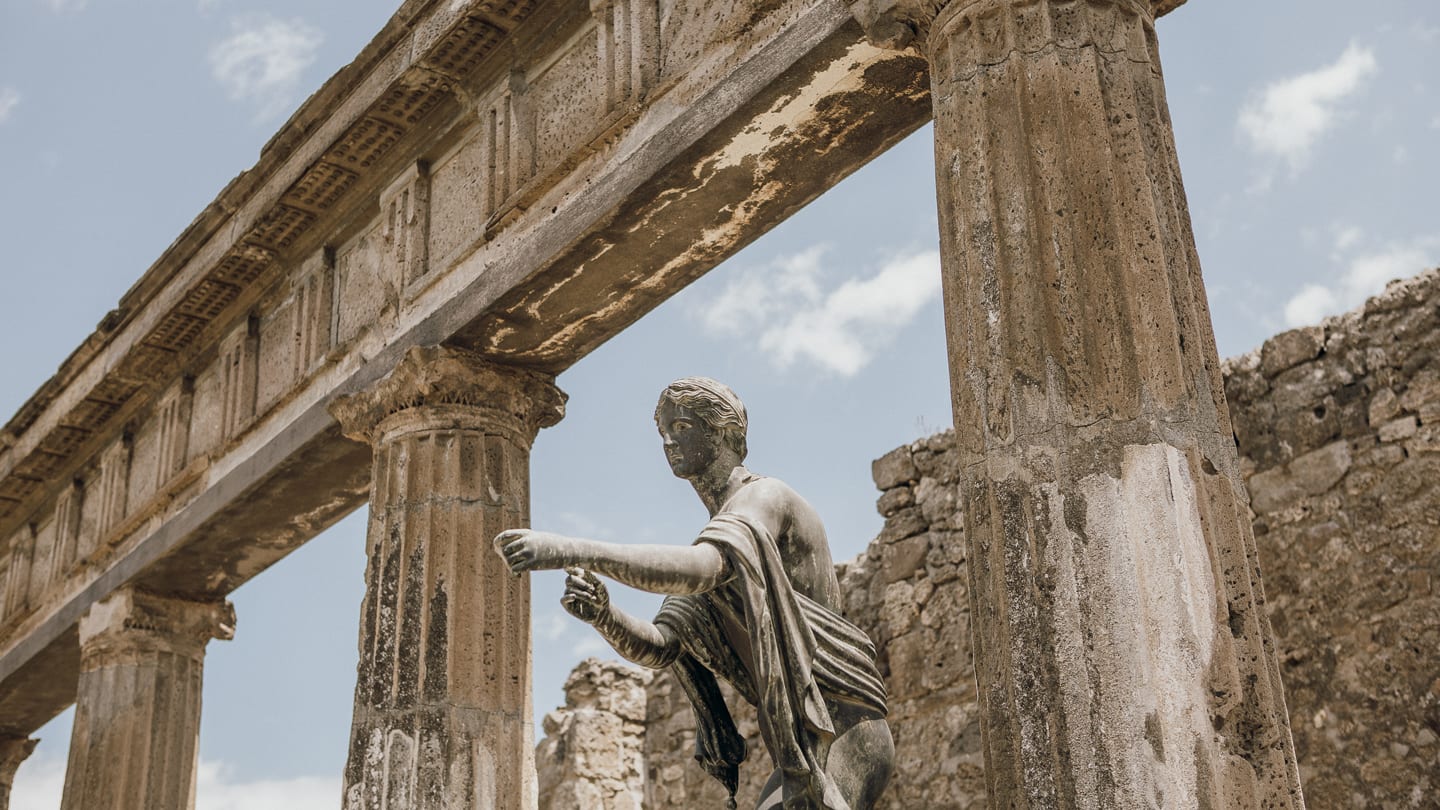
1225, 271, 1440, 809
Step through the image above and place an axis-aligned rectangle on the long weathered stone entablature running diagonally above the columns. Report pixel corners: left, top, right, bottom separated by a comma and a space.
0, 0, 956, 735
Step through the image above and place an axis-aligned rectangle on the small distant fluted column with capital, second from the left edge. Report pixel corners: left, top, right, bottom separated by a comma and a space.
60, 588, 235, 810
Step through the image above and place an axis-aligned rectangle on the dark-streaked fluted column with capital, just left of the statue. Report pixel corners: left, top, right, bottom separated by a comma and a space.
331, 347, 564, 810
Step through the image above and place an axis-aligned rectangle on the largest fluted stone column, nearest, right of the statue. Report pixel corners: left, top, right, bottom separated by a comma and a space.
852, 0, 1302, 809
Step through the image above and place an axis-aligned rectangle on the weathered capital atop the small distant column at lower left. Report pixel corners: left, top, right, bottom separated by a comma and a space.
81, 588, 235, 672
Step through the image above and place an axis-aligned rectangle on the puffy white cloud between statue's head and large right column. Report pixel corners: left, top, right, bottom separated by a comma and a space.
700, 246, 940, 376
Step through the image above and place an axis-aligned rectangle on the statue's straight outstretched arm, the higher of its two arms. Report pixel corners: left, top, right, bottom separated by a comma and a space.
495, 529, 729, 595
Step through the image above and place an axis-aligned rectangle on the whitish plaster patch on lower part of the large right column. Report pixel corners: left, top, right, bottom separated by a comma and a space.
1051, 444, 1220, 809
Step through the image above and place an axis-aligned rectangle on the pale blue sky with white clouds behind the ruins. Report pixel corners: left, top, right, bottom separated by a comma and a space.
0, 0, 1440, 810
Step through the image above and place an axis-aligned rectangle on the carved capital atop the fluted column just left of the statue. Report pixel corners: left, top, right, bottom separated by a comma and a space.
330, 346, 567, 445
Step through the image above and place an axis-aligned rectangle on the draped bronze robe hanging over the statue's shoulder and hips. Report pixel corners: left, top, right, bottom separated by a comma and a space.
655, 512, 886, 810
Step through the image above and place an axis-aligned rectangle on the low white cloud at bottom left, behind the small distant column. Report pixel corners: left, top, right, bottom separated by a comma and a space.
10, 757, 340, 810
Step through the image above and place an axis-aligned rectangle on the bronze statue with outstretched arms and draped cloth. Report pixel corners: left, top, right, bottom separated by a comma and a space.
495, 378, 894, 810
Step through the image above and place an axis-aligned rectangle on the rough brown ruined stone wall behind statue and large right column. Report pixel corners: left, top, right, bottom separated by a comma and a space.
541, 270, 1440, 810
